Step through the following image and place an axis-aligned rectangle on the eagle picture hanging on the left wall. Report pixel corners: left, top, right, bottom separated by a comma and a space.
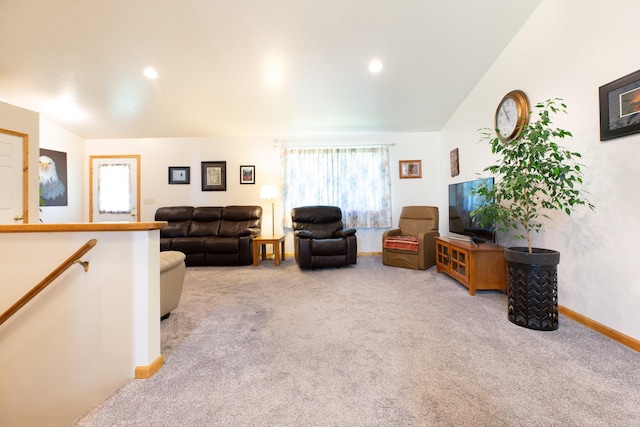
38, 148, 68, 206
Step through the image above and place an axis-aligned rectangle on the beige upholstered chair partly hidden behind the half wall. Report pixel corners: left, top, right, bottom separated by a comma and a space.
160, 251, 186, 320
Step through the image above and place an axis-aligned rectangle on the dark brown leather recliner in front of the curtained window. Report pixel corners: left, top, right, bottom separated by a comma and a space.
291, 206, 358, 269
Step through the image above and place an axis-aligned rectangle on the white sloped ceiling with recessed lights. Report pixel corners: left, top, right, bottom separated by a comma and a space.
0, 0, 540, 138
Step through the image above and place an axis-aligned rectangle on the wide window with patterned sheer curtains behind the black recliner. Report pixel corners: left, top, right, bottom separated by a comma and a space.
282, 146, 391, 228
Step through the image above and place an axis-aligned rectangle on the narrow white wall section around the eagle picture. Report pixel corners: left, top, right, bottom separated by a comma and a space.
40, 119, 85, 224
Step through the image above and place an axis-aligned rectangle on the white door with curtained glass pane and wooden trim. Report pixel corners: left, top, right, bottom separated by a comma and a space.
89, 155, 140, 222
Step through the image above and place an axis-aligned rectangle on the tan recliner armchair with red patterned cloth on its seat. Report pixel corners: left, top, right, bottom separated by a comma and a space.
382, 206, 440, 270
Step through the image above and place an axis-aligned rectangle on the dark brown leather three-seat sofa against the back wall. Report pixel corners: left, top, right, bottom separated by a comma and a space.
155, 206, 262, 266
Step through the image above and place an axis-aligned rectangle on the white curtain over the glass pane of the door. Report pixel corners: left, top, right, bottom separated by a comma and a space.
98, 164, 132, 214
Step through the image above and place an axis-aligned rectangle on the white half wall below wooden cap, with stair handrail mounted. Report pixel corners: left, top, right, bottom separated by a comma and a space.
0, 224, 160, 426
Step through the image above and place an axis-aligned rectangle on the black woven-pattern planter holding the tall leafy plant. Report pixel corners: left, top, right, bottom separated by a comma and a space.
504, 247, 560, 331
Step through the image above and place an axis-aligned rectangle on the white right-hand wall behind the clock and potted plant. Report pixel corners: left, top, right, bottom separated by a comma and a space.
441, 0, 640, 339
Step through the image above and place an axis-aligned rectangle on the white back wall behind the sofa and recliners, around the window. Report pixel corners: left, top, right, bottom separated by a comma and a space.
84, 132, 442, 253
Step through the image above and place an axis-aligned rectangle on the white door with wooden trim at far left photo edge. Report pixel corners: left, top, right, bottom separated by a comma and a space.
0, 129, 29, 224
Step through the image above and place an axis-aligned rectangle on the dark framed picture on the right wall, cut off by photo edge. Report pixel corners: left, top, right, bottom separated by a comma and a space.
600, 70, 640, 141
